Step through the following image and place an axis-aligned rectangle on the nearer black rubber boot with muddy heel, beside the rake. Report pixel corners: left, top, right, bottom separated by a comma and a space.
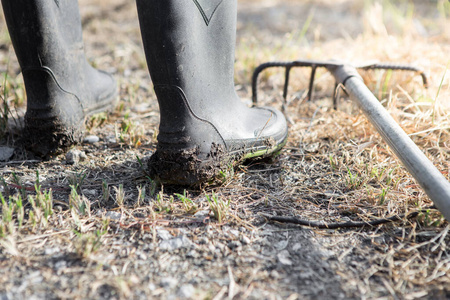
137, 0, 287, 185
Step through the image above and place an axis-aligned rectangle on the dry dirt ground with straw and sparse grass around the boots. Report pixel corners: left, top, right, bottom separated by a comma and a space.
0, 0, 450, 300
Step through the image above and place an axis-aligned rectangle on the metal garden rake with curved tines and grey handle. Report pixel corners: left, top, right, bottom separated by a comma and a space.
252, 60, 450, 221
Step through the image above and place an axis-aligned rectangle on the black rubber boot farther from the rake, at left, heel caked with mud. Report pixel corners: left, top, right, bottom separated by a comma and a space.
2, 0, 116, 156
